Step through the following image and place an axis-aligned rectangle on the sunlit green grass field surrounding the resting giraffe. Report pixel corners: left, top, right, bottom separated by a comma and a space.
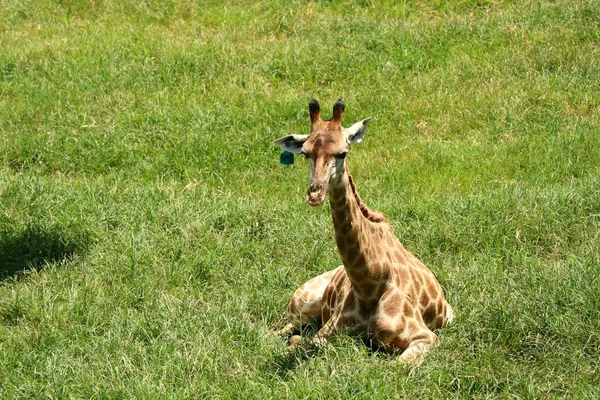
0, 0, 600, 399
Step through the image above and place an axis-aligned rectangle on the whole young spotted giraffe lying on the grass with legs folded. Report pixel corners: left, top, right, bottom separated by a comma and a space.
275, 100, 454, 361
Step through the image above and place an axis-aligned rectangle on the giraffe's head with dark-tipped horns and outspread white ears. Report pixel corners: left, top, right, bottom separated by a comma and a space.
275, 99, 371, 206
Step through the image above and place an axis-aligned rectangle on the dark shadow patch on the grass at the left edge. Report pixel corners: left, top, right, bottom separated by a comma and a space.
0, 225, 90, 282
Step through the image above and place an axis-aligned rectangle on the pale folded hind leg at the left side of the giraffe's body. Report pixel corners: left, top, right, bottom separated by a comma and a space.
276, 266, 343, 343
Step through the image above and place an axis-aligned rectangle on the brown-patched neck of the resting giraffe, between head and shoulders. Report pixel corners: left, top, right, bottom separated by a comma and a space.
329, 168, 395, 298
